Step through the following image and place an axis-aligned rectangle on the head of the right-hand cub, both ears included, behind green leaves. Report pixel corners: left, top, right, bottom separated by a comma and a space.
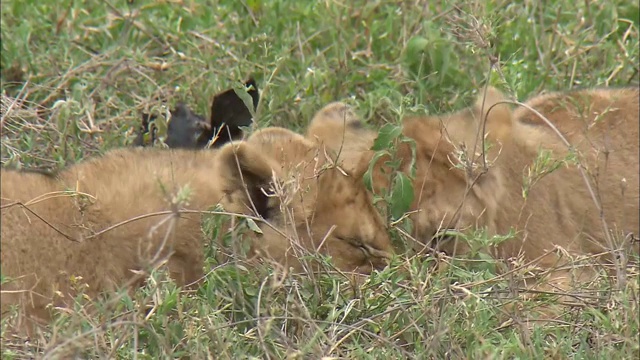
307, 87, 511, 253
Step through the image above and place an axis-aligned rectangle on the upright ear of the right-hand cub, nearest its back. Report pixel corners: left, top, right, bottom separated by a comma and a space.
474, 86, 512, 140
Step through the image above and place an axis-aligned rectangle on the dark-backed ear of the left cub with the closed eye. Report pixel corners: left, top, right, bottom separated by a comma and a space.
217, 141, 280, 218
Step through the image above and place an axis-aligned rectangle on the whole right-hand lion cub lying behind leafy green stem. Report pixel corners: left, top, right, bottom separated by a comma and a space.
307, 88, 640, 282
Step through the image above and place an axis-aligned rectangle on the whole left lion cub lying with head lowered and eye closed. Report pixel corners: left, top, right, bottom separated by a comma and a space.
1, 128, 393, 334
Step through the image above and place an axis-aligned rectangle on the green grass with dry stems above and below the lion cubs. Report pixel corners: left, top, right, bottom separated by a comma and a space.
0, 0, 640, 359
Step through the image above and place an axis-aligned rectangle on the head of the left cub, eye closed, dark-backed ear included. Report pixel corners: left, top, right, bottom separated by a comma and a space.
218, 128, 393, 273
